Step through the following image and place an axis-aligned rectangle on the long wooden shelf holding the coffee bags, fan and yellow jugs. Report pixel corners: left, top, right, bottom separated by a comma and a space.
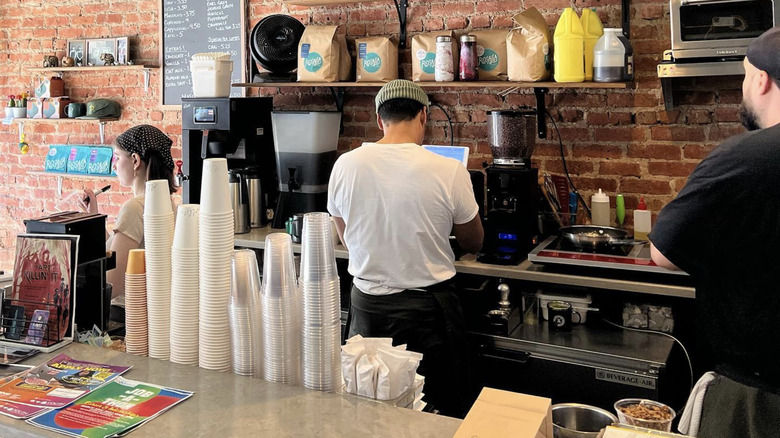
232, 81, 630, 89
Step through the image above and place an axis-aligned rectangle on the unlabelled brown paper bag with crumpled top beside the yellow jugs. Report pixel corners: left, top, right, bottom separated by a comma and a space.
506, 7, 552, 82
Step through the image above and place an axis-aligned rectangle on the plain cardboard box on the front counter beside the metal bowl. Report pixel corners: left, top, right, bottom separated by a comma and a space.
454, 388, 553, 438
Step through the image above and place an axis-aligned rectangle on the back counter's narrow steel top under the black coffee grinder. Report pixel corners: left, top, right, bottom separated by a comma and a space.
235, 227, 696, 298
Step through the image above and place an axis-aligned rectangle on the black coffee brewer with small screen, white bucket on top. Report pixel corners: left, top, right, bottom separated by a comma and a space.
181, 97, 276, 227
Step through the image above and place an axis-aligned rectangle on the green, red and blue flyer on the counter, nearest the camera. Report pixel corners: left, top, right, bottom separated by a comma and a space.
27, 377, 192, 438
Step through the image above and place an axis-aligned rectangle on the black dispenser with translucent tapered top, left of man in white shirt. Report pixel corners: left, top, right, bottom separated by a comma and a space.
271, 111, 341, 228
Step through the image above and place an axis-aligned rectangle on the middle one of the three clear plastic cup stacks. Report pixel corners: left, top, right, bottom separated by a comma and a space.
260, 233, 301, 384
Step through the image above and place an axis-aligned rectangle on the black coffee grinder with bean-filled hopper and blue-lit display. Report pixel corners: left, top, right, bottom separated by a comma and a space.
477, 109, 539, 265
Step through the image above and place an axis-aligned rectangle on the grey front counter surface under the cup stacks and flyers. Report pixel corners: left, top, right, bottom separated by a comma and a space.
0, 344, 461, 438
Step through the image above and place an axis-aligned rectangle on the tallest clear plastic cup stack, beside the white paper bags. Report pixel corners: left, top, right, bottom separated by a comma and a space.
299, 213, 342, 391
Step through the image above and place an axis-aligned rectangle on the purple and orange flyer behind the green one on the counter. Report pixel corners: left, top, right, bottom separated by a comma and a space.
0, 354, 130, 409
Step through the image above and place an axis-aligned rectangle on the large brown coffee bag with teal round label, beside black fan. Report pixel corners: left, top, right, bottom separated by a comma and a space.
298, 26, 342, 82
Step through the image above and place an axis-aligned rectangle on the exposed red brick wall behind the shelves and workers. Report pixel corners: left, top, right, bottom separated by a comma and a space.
0, 0, 741, 268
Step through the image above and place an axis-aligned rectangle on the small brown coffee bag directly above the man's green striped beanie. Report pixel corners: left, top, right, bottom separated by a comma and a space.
355, 37, 398, 82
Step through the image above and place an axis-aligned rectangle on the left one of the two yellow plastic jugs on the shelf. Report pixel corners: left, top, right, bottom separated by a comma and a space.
553, 8, 585, 82
